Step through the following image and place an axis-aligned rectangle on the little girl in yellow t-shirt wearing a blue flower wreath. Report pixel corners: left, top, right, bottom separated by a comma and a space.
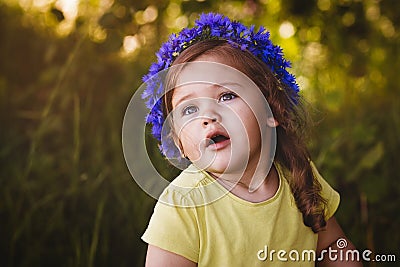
142, 13, 361, 266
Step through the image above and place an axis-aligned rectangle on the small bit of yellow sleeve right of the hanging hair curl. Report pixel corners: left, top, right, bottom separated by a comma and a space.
311, 162, 340, 220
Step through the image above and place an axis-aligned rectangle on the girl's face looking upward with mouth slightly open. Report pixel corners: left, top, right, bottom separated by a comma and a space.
171, 56, 276, 177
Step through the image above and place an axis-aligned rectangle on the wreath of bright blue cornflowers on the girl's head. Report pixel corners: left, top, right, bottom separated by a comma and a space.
142, 13, 299, 158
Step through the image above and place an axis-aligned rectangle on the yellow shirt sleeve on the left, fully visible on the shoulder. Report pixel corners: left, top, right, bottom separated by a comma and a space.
142, 193, 200, 262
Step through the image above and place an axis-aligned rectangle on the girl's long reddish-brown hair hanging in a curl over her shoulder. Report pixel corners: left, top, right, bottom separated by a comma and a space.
163, 40, 326, 233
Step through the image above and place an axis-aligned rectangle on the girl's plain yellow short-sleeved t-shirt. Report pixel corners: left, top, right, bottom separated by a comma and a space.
142, 163, 339, 267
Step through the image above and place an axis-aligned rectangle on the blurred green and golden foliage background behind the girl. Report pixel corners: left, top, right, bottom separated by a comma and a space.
0, 0, 400, 266
